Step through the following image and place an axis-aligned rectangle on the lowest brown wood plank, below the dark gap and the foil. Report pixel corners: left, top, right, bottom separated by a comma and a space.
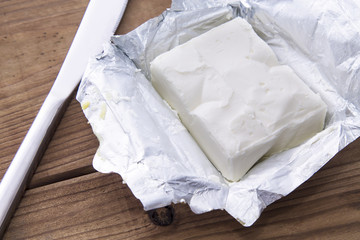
4, 140, 360, 240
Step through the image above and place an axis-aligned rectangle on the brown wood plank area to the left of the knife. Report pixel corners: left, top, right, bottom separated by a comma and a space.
0, 0, 88, 178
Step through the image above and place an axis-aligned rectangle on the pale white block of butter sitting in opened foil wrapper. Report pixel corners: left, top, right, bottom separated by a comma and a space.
150, 18, 327, 181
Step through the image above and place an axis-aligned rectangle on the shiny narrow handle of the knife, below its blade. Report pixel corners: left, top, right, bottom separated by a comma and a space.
0, 91, 70, 238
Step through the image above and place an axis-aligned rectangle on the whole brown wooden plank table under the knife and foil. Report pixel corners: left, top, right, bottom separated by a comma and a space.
0, 0, 360, 239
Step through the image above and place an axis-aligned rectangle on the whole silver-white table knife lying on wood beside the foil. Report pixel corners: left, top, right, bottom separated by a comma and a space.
0, 0, 128, 235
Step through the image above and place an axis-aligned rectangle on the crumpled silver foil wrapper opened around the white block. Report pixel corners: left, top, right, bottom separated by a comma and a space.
77, 0, 360, 226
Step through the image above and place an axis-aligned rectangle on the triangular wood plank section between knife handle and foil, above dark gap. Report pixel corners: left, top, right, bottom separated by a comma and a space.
29, 94, 98, 188
